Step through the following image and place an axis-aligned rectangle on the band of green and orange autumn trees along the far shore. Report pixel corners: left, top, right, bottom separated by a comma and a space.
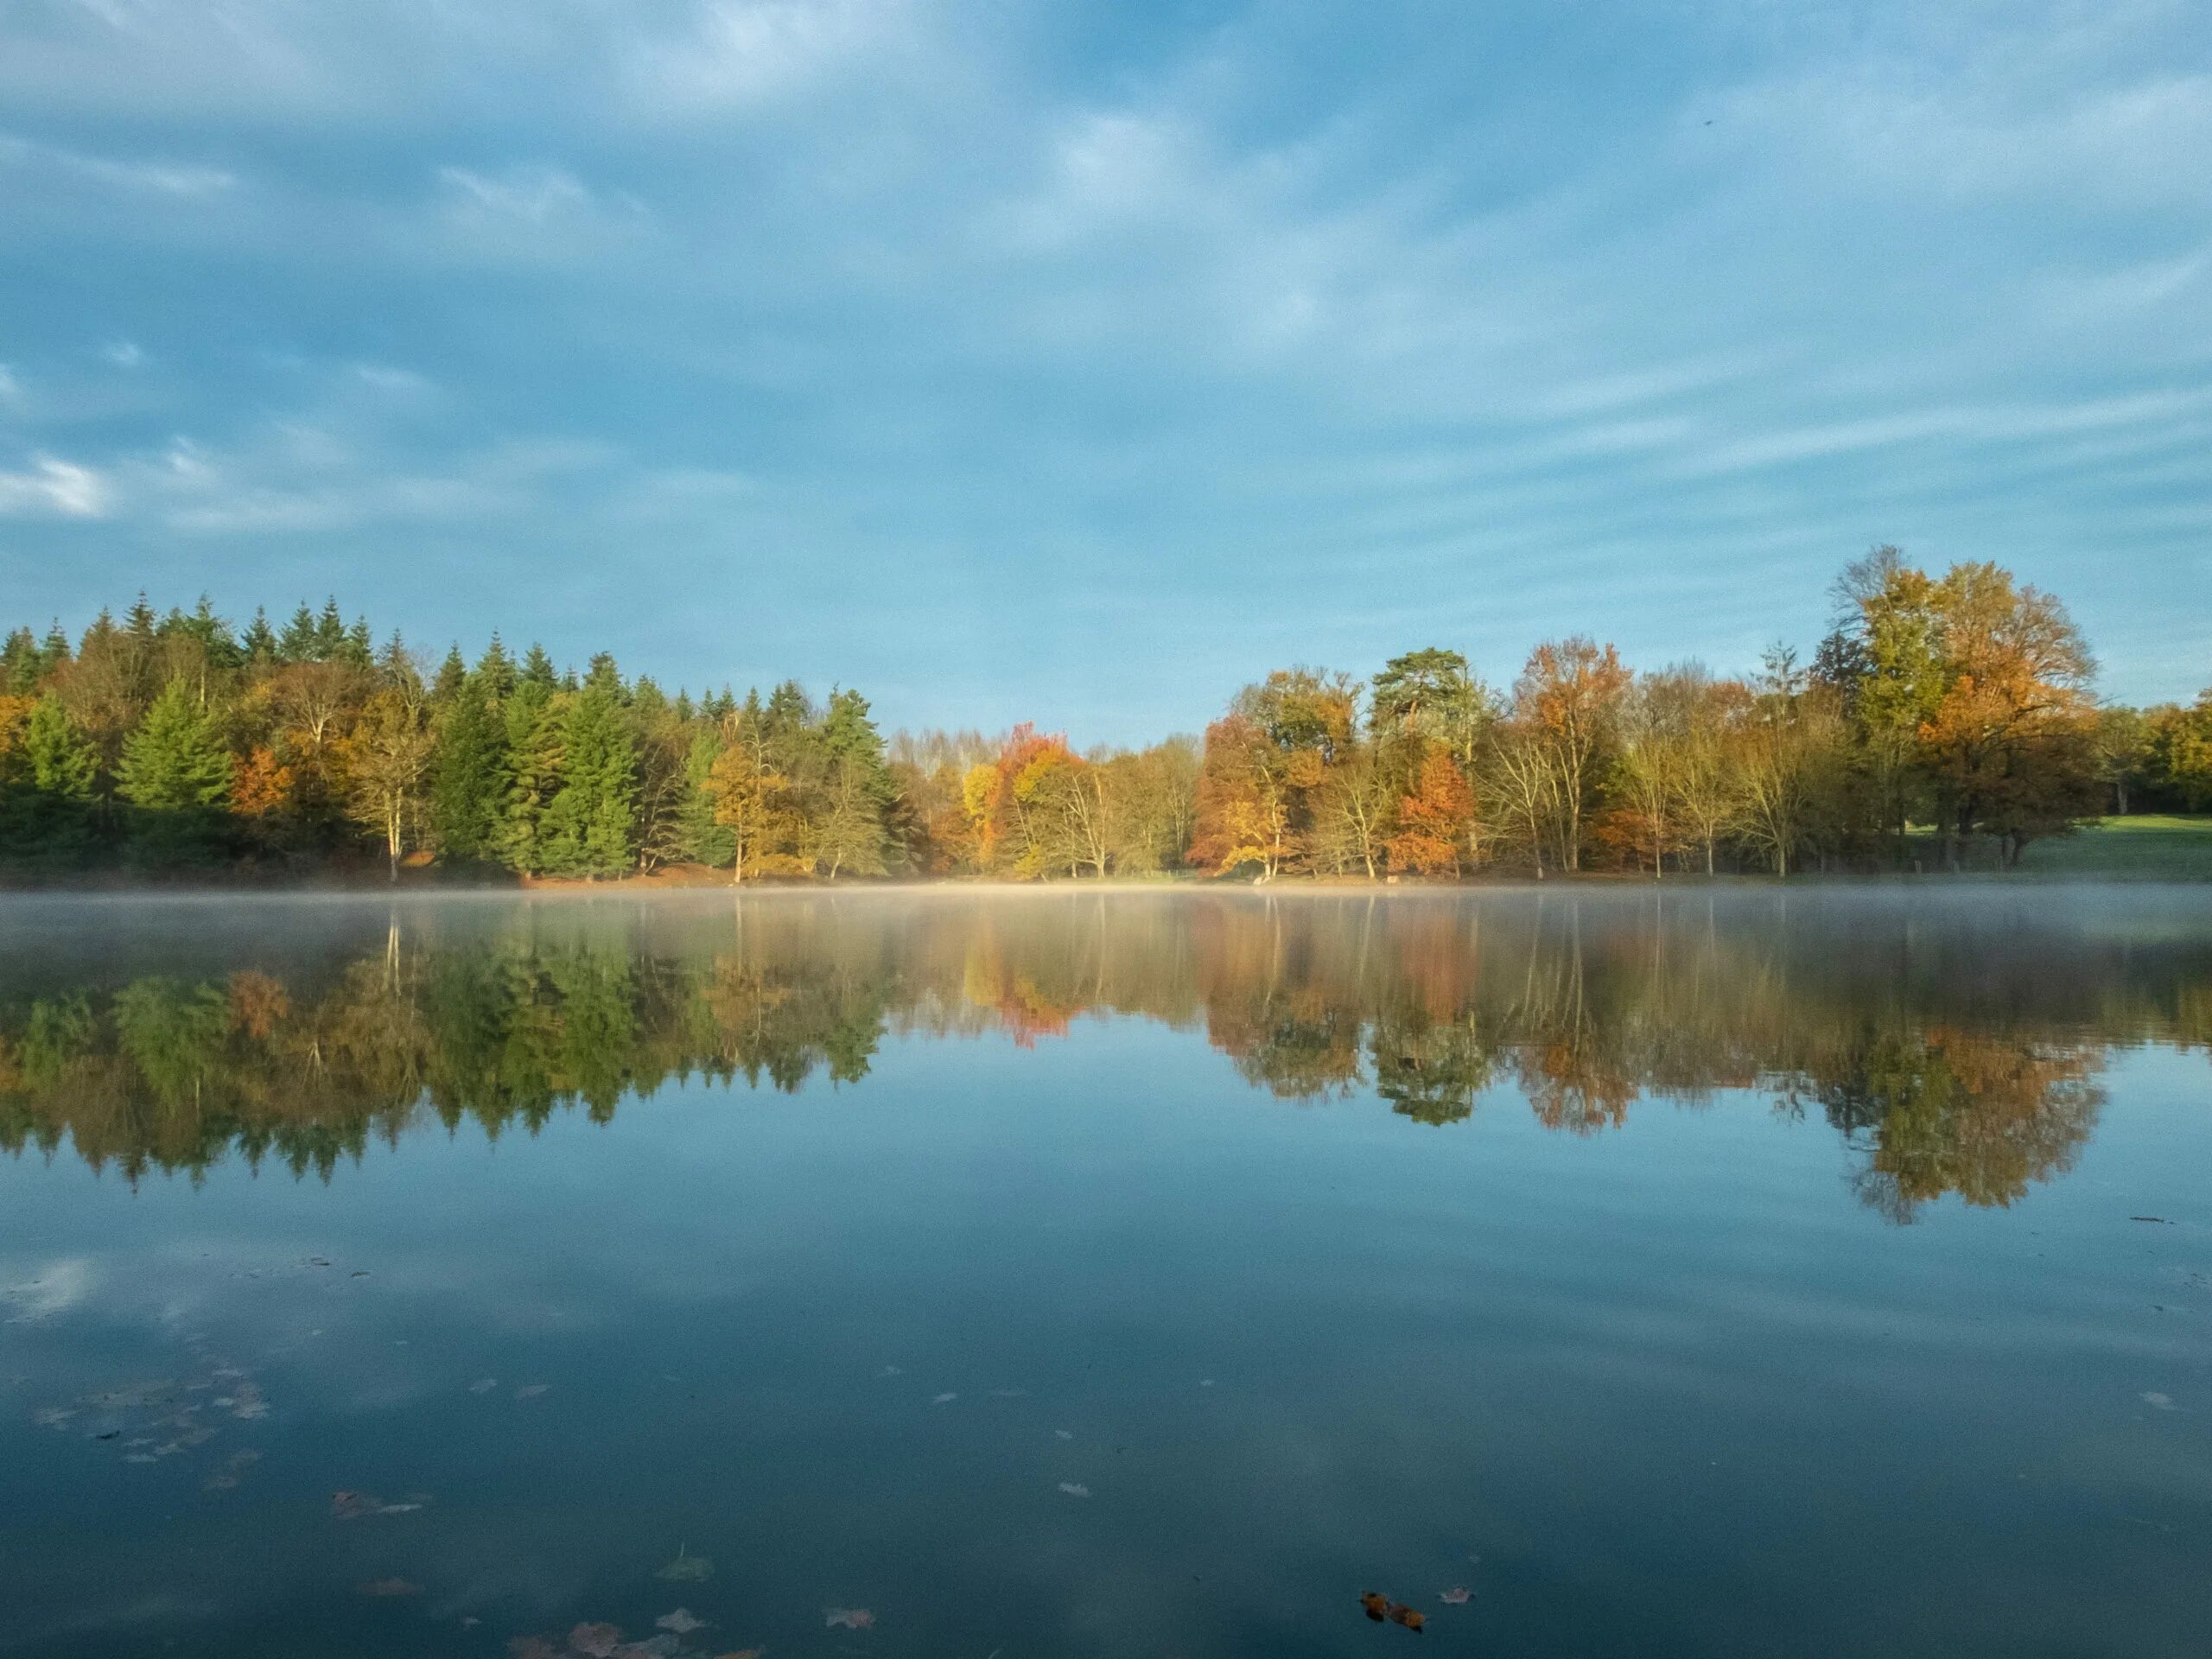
0, 546, 2212, 882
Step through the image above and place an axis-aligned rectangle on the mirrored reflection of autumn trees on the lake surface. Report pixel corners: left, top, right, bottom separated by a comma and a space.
0, 892, 2212, 1221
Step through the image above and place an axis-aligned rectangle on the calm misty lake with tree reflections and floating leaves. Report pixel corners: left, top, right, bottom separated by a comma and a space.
0, 898, 2212, 1659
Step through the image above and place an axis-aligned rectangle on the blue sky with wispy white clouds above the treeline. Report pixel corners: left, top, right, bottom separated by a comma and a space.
0, 0, 2212, 743
